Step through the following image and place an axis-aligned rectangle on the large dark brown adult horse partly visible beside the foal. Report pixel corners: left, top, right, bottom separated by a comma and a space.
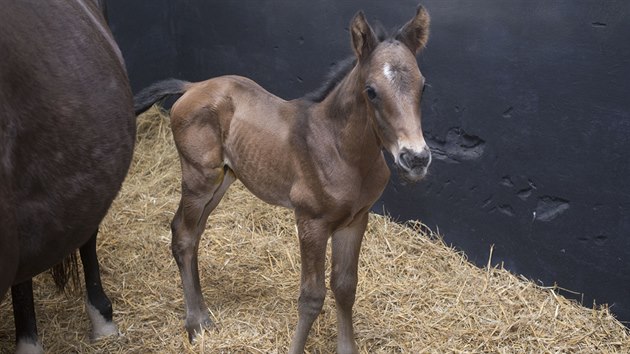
0, 0, 135, 352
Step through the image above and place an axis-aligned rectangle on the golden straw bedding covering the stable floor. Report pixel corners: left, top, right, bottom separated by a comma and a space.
0, 108, 630, 353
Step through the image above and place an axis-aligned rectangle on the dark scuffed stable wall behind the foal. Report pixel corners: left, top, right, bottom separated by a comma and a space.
109, 0, 630, 320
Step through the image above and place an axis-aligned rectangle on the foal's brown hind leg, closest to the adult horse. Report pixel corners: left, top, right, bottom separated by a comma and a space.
171, 165, 236, 342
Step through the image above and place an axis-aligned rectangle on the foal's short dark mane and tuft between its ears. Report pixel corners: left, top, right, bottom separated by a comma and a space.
304, 22, 398, 103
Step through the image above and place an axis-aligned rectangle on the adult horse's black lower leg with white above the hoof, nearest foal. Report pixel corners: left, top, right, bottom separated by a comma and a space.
80, 230, 118, 340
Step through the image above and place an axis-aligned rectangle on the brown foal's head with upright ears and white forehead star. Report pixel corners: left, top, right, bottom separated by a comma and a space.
350, 6, 431, 182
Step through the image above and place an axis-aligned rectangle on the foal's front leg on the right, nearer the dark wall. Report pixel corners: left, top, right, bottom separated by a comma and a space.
330, 212, 368, 353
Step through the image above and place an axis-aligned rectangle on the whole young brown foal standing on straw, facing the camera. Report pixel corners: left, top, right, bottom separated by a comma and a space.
136, 7, 431, 353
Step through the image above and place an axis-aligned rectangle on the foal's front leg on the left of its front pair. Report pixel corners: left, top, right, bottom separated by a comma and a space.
289, 216, 329, 354
